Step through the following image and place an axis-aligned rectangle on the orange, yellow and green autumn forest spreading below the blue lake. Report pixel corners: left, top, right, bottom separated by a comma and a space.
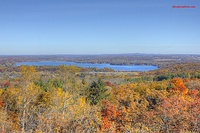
0, 54, 200, 133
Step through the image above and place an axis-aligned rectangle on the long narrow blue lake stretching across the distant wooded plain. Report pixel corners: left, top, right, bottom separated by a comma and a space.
16, 61, 158, 71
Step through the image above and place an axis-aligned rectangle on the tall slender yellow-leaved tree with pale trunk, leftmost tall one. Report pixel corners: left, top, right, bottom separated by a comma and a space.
17, 66, 40, 133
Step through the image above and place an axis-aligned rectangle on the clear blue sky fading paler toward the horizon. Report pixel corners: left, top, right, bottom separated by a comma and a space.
0, 0, 200, 55
